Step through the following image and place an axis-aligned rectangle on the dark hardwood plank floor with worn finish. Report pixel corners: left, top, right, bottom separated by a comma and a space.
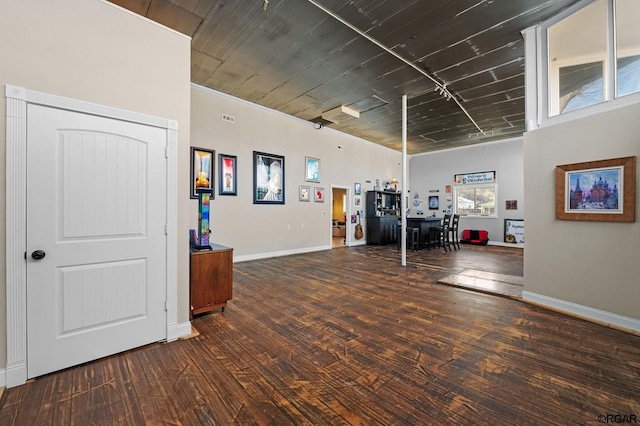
0, 246, 640, 425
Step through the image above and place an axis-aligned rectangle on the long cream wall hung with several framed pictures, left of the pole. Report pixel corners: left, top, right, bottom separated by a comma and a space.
189, 85, 402, 261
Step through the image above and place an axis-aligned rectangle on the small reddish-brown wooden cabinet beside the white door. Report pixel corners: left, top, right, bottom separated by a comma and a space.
189, 244, 233, 317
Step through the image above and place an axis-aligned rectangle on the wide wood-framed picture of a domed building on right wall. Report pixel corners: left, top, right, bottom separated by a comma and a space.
555, 156, 636, 222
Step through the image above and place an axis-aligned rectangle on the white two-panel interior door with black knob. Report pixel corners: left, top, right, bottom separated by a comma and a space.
26, 104, 167, 377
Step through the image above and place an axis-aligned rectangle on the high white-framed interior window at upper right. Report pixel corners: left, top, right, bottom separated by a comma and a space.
543, 0, 640, 117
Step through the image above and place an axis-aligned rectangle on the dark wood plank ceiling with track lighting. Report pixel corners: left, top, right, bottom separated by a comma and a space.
111, 0, 577, 154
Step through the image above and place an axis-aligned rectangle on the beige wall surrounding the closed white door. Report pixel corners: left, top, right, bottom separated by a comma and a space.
0, 0, 191, 365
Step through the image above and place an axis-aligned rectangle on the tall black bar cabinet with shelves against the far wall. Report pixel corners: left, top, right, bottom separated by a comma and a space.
365, 191, 400, 245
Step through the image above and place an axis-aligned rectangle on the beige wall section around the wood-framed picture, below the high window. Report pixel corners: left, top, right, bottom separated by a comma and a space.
524, 104, 640, 324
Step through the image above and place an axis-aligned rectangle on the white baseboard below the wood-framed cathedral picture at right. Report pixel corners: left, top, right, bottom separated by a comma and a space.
522, 291, 640, 334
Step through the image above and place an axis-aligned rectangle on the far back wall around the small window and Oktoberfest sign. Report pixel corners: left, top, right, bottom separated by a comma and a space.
409, 138, 529, 246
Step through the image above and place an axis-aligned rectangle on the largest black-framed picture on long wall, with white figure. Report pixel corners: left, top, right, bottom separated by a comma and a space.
253, 151, 285, 204
